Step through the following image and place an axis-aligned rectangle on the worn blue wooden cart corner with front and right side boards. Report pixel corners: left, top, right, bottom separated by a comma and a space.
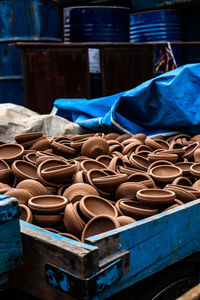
10, 200, 200, 300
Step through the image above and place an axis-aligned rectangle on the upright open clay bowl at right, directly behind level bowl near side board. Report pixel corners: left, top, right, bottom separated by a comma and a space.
149, 165, 183, 184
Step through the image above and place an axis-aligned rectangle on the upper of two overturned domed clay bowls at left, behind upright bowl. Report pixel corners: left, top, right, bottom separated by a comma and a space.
16, 179, 48, 197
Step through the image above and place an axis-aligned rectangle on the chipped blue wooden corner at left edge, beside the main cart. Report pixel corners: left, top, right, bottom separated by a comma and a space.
0, 195, 22, 289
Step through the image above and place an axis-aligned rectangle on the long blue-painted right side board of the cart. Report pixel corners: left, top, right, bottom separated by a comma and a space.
87, 200, 200, 299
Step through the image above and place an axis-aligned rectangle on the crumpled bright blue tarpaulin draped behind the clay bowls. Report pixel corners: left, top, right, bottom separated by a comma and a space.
54, 64, 200, 134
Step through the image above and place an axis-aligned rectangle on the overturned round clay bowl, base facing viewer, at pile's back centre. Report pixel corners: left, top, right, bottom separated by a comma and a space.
81, 137, 109, 158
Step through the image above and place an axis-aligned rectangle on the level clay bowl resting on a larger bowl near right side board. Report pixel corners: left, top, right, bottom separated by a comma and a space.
136, 189, 175, 207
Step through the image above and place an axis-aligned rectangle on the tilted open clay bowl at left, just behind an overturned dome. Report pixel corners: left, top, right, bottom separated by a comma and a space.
12, 160, 38, 181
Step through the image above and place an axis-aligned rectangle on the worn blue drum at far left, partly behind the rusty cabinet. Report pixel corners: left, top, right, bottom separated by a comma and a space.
0, 0, 61, 105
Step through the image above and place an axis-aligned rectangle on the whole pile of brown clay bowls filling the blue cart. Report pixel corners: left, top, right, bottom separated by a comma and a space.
0, 132, 200, 241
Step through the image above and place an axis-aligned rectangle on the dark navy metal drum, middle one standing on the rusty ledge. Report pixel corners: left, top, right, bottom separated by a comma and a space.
64, 6, 130, 43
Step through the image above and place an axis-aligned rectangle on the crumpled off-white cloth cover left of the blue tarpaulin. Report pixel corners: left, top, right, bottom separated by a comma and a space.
0, 103, 85, 142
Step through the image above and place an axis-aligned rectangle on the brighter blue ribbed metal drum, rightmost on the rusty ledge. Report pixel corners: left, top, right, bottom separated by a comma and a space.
130, 10, 181, 42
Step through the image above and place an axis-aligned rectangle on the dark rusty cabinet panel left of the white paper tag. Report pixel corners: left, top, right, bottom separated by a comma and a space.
22, 47, 90, 114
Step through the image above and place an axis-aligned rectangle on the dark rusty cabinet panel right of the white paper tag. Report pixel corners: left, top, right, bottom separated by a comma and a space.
101, 46, 154, 96
